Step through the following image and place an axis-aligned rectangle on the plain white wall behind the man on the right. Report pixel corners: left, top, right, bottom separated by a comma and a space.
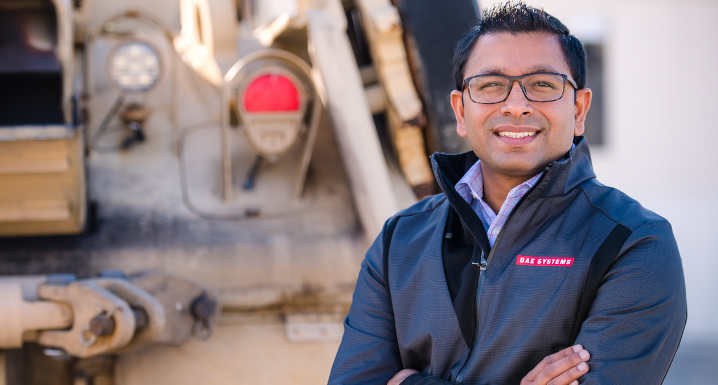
524, 0, 718, 343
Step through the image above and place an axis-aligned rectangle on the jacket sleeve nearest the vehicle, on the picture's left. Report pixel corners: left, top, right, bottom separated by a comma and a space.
329, 220, 456, 385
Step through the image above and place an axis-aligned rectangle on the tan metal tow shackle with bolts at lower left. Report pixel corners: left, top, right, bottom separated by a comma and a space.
0, 270, 219, 358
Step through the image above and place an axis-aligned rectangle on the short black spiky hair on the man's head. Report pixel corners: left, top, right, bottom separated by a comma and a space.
454, 1, 586, 91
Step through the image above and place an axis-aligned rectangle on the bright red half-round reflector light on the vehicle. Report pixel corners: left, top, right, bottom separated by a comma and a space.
244, 75, 299, 112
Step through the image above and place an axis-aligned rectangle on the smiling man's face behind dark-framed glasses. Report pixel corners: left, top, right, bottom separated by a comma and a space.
451, 32, 591, 177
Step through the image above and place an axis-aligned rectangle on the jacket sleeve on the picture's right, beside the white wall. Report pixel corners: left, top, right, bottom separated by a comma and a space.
576, 220, 687, 385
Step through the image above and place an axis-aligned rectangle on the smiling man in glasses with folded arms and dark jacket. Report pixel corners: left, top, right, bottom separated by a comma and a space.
329, 3, 686, 385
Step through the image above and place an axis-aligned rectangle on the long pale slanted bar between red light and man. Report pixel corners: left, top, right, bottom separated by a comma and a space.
308, 6, 399, 239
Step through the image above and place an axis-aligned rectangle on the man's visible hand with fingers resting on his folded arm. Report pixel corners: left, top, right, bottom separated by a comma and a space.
521, 345, 591, 385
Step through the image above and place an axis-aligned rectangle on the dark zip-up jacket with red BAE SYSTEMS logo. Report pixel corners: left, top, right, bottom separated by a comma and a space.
329, 137, 686, 385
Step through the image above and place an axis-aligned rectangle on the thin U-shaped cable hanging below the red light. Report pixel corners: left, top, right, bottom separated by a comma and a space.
178, 121, 317, 221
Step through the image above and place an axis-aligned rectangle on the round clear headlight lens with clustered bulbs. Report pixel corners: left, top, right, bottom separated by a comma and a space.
108, 41, 162, 92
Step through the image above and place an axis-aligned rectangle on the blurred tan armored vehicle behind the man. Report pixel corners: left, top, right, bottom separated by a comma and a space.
0, 0, 484, 385
